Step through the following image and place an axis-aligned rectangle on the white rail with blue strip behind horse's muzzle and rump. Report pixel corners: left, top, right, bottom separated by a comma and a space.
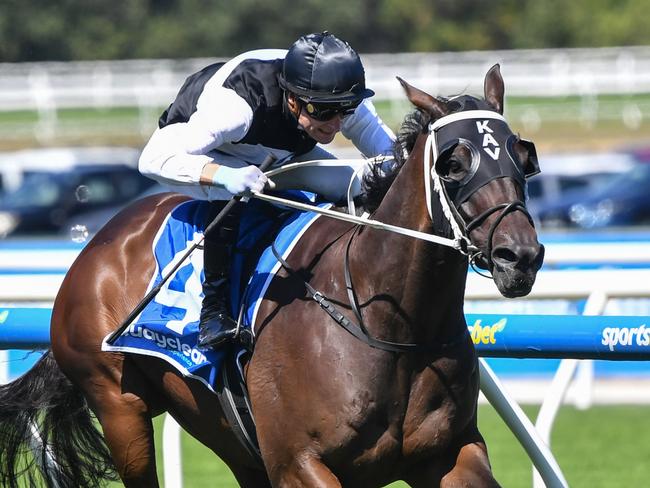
0, 241, 650, 304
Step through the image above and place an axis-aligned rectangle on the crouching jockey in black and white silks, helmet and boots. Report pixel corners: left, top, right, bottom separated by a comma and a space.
139, 32, 395, 348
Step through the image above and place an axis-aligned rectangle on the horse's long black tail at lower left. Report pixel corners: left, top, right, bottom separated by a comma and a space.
0, 351, 117, 488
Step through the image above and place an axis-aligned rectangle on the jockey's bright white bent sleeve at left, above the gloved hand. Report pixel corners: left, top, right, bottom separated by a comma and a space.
139, 87, 253, 187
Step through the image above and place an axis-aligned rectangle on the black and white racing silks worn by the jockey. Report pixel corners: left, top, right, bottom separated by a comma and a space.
140, 49, 394, 200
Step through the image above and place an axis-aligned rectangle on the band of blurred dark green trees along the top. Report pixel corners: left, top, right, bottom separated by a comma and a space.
0, 0, 650, 61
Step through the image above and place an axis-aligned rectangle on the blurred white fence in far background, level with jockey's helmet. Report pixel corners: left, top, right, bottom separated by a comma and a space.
0, 46, 650, 142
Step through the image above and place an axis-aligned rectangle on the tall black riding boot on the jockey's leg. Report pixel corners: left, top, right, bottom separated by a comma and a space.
198, 204, 252, 349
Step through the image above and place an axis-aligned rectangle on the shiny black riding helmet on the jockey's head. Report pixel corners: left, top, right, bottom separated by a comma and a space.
280, 31, 375, 106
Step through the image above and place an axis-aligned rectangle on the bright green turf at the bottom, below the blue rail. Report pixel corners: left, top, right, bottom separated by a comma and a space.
102, 406, 650, 488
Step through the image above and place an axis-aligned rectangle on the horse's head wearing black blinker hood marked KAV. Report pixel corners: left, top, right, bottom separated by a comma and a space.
399, 65, 544, 297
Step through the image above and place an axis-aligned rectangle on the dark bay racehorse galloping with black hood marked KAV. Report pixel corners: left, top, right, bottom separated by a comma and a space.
0, 65, 543, 488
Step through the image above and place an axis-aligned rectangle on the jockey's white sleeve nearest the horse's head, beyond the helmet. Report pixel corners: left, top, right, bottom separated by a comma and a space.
341, 99, 395, 157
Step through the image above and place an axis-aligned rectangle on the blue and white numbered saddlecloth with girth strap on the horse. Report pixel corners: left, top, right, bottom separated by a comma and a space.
102, 192, 330, 464
